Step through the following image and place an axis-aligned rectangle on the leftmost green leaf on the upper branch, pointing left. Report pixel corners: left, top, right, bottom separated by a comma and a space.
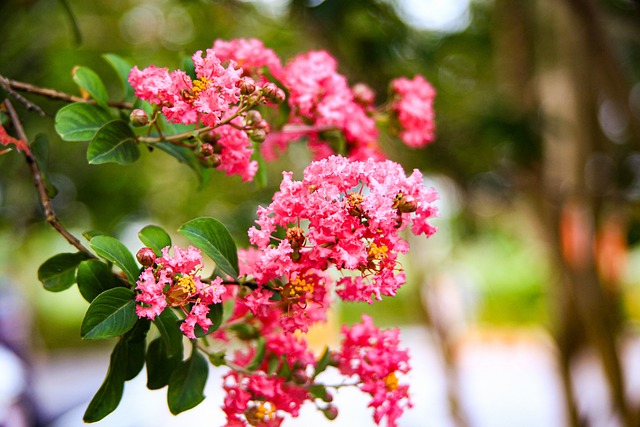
55, 102, 113, 141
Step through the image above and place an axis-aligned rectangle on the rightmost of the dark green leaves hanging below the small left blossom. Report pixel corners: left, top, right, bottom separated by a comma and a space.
167, 346, 209, 415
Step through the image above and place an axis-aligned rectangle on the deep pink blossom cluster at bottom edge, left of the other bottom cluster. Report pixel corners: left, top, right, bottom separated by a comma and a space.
222, 333, 316, 427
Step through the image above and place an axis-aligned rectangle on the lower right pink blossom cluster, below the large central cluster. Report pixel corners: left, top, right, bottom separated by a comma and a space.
334, 315, 412, 427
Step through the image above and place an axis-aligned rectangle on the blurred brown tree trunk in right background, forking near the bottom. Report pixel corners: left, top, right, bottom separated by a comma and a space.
496, 0, 636, 426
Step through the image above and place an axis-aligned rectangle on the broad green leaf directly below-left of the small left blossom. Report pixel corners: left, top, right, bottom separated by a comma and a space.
80, 288, 138, 340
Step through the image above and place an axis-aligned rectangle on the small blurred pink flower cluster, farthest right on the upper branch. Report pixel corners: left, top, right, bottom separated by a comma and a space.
391, 75, 436, 148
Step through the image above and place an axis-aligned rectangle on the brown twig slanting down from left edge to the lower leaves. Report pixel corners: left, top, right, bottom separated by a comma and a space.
4, 99, 95, 258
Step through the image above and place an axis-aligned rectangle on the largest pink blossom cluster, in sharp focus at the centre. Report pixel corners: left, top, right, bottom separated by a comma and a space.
249, 156, 438, 303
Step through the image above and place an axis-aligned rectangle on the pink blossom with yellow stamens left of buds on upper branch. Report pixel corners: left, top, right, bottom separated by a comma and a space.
129, 49, 242, 126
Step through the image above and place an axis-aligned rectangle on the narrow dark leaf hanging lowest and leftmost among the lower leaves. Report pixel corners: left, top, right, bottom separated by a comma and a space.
82, 341, 127, 423
